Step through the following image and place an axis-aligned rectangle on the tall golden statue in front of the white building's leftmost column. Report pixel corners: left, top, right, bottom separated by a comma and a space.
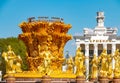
75, 47, 86, 76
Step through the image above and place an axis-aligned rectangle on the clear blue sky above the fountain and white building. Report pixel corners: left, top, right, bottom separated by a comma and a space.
0, 0, 120, 55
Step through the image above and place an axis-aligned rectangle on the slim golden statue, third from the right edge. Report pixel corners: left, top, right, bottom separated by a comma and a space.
91, 54, 98, 79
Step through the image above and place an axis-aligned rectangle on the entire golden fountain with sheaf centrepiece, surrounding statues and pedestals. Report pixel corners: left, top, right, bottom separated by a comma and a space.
2, 17, 120, 83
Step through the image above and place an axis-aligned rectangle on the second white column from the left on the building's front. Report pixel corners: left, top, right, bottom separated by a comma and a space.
85, 44, 89, 80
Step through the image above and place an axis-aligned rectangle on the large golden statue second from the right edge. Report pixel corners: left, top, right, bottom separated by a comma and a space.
99, 49, 108, 77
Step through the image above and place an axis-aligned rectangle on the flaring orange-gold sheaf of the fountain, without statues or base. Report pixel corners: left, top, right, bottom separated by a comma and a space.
19, 18, 72, 72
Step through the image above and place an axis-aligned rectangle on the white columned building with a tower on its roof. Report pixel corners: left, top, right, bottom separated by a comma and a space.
74, 12, 120, 79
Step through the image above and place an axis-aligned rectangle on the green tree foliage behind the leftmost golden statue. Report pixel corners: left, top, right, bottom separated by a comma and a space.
0, 37, 28, 72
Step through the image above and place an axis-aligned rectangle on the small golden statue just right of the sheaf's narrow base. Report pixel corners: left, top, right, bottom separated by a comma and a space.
66, 56, 74, 73
